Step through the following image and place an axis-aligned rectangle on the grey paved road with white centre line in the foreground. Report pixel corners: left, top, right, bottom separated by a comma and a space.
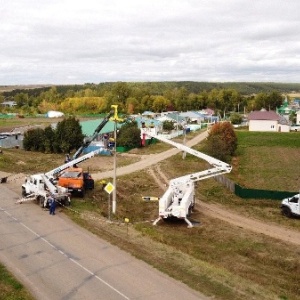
0, 165, 206, 300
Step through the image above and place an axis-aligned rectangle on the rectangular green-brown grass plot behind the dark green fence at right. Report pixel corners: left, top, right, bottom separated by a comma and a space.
231, 132, 300, 191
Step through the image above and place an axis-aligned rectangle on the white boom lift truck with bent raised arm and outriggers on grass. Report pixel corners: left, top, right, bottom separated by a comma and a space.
144, 130, 232, 227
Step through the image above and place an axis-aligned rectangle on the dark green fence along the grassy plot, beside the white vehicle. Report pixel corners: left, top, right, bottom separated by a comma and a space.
234, 184, 299, 200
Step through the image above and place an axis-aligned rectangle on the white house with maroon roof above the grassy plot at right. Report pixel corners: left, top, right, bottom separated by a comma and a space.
248, 109, 290, 132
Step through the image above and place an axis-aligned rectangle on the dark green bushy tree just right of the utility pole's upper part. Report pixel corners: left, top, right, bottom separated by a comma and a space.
117, 121, 141, 148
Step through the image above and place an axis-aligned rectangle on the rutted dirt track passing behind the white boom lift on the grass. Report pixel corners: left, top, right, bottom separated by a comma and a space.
149, 165, 300, 246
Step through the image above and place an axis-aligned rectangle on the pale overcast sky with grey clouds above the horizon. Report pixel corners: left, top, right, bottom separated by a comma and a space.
0, 0, 300, 86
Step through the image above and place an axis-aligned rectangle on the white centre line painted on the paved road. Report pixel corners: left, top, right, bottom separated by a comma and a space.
0, 207, 130, 300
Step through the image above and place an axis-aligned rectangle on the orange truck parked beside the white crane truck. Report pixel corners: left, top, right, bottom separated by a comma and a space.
58, 167, 94, 197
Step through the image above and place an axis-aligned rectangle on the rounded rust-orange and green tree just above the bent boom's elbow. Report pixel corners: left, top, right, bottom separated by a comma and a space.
206, 122, 237, 161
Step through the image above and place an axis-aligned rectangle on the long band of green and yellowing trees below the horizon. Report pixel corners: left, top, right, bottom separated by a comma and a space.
0, 82, 300, 115
